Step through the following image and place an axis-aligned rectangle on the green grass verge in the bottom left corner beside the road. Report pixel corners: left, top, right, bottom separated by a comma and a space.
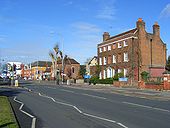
0, 96, 19, 128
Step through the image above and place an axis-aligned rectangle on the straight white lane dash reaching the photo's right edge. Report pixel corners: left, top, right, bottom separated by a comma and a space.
122, 102, 170, 112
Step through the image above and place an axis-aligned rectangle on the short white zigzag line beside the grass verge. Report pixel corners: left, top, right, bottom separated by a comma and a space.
14, 97, 36, 128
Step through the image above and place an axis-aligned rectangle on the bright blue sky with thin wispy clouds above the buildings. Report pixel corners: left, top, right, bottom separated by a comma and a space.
0, 0, 170, 64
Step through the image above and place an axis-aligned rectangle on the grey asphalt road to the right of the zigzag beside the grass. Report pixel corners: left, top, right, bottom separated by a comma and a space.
0, 82, 170, 128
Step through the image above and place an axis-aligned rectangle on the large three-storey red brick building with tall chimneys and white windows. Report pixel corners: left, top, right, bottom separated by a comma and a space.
98, 18, 166, 81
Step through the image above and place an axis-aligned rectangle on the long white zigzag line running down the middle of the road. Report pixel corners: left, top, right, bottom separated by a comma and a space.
39, 93, 128, 128
